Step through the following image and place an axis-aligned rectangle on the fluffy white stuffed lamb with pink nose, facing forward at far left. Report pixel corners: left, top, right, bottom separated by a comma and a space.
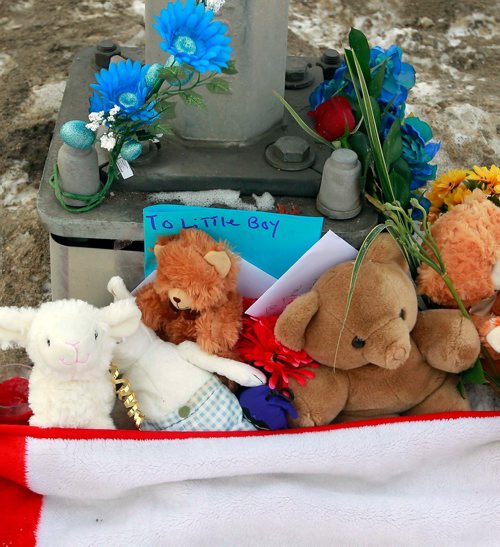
0, 300, 141, 429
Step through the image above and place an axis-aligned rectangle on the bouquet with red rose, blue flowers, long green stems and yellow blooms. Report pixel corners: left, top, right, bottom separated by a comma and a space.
278, 29, 500, 395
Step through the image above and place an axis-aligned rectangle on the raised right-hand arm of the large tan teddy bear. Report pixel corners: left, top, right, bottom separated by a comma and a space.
411, 309, 480, 373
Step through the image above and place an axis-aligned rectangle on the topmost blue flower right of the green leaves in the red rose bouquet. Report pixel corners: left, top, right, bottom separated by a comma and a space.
370, 45, 415, 106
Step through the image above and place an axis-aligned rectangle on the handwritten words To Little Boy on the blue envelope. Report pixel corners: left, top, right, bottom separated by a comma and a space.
145, 215, 281, 239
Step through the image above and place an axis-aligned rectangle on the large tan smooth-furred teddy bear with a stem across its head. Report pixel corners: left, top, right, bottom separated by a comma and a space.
275, 234, 480, 427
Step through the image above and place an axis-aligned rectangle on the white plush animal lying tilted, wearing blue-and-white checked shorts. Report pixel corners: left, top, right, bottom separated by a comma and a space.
108, 277, 266, 431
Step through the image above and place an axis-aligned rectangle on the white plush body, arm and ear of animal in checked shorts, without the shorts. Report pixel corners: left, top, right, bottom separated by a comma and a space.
108, 277, 266, 421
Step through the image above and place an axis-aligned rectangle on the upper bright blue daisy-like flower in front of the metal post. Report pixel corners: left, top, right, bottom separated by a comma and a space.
153, 0, 232, 73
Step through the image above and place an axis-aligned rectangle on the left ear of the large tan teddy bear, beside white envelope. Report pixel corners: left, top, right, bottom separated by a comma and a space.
274, 291, 319, 351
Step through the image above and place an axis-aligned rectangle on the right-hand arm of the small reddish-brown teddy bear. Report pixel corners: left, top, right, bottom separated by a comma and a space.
196, 293, 243, 356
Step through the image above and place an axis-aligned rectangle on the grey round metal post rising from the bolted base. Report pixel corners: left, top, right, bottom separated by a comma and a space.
146, 0, 288, 144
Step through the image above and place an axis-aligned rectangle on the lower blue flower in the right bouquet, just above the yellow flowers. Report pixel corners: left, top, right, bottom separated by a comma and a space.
401, 116, 441, 190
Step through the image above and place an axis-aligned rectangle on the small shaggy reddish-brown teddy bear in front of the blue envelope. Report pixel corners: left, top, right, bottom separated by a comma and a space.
137, 229, 243, 357
